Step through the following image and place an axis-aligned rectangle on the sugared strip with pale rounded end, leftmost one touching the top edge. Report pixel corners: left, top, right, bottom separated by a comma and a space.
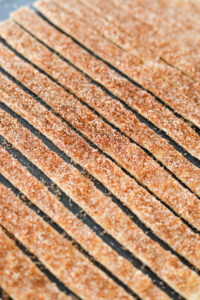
32, 0, 200, 127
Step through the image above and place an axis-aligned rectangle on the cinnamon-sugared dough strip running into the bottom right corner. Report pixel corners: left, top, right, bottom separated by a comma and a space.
0, 110, 200, 299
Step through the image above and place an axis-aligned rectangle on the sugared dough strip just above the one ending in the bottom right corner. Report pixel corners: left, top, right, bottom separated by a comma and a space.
0, 75, 200, 267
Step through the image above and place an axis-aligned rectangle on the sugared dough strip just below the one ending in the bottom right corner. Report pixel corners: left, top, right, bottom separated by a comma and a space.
0, 147, 169, 300
